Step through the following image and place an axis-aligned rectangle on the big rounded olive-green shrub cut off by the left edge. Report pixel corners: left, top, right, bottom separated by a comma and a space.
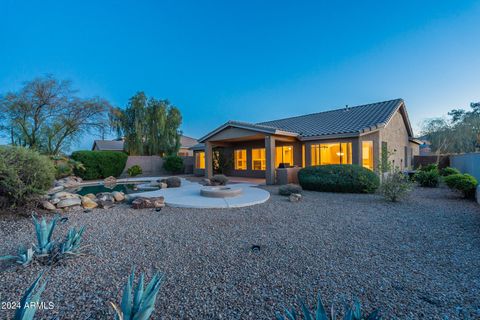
0, 146, 55, 206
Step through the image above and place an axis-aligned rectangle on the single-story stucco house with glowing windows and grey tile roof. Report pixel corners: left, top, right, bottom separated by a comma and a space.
191, 99, 420, 184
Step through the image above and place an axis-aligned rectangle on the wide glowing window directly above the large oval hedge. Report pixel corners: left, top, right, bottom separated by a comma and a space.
311, 142, 352, 166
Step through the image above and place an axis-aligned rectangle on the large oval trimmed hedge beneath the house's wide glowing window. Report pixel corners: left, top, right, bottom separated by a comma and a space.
298, 164, 380, 193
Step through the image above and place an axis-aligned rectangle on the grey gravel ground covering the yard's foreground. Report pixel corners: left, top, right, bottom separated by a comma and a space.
0, 187, 480, 319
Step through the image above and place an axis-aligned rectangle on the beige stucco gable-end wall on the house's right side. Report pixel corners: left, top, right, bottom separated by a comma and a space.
380, 112, 412, 170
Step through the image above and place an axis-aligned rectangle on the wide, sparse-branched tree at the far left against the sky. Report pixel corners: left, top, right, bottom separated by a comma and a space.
0, 76, 111, 154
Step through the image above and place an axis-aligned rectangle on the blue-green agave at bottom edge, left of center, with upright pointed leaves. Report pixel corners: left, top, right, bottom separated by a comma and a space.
110, 270, 163, 320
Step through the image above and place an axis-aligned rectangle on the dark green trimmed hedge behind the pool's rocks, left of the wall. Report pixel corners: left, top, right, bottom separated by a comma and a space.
72, 151, 128, 180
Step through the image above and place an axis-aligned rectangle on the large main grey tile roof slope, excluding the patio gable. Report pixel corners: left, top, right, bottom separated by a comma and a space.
255, 99, 403, 137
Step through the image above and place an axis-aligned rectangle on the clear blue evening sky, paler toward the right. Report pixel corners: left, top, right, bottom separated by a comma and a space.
0, 0, 480, 148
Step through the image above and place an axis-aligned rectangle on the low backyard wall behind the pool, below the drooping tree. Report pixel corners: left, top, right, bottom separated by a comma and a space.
121, 156, 194, 177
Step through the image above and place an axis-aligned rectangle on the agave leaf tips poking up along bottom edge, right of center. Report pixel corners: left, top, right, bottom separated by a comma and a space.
276, 293, 382, 320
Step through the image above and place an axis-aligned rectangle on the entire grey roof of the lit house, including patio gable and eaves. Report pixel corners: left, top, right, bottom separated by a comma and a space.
199, 99, 413, 142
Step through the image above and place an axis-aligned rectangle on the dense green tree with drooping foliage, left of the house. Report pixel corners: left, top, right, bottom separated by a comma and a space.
110, 92, 182, 155
